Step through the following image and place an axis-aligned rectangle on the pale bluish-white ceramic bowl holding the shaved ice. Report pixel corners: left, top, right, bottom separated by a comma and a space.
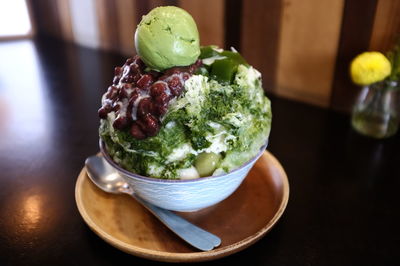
100, 141, 267, 212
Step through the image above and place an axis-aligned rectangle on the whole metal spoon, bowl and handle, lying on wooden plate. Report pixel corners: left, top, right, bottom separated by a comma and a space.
85, 155, 221, 251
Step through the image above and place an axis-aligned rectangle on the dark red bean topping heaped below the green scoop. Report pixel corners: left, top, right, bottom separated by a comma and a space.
98, 56, 202, 139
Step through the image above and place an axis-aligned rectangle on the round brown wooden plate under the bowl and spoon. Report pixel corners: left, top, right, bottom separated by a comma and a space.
75, 151, 289, 262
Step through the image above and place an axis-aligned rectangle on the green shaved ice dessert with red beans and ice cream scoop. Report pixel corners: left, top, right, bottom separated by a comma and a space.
99, 7, 271, 179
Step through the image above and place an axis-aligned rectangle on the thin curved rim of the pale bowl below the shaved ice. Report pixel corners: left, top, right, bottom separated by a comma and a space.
99, 138, 269, 183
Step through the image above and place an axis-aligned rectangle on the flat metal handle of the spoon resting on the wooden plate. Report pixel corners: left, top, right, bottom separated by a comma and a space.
134, 193, 221, 251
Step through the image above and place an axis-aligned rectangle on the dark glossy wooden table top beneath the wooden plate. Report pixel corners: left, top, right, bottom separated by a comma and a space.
0, 35, 400, 266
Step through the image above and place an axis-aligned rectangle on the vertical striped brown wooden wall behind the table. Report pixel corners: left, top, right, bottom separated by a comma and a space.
27, 0, 400, 111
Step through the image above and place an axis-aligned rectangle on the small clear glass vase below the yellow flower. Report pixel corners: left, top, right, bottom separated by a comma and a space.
351, 81, 400, 139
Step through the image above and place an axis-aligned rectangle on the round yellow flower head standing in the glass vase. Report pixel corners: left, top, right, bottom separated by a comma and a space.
350, 52, 392, 85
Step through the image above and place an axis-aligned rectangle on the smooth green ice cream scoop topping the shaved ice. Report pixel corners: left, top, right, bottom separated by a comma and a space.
135, 6, 200, 71
